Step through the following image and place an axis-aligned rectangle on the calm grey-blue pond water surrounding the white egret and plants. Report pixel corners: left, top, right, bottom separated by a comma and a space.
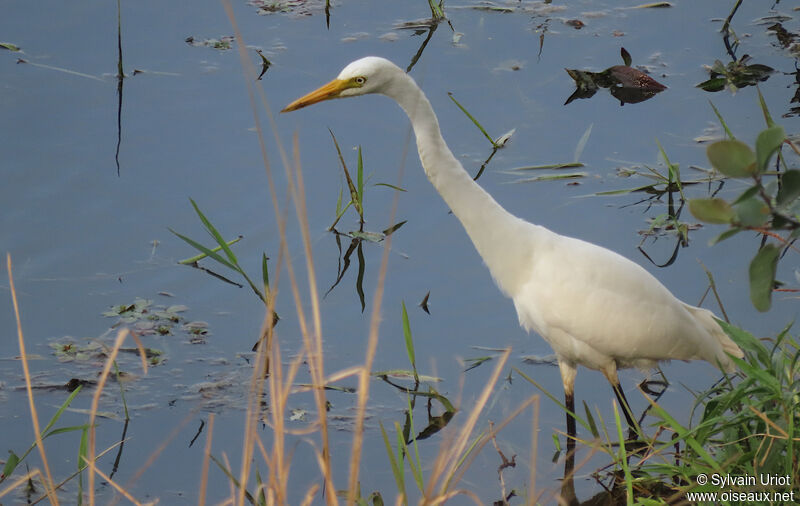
0, 0, 798, 504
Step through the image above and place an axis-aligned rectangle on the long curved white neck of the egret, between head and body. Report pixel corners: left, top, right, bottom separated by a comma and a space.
386, 75, 530, 295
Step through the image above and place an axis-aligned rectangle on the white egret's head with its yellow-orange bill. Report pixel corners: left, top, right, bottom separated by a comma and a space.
281, 56, 405, 112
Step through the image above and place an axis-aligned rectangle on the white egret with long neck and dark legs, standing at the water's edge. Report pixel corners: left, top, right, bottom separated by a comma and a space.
281, 56, 743, 434
